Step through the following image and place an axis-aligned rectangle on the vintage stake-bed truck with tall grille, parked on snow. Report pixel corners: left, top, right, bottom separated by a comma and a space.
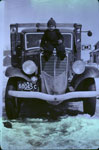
5, 23, 99, 119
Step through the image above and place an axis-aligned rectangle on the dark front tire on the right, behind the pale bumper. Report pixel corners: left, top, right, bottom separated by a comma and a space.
83, 83, 96, 116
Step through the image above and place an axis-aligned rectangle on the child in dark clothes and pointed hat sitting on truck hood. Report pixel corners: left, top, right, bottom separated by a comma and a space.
40, 18, 66, 60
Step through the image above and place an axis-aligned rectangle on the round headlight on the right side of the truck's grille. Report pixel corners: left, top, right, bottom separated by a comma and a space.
72, 60, 85, 74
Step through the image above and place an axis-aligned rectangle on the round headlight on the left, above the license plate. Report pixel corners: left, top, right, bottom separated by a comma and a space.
22, 60, 37, 75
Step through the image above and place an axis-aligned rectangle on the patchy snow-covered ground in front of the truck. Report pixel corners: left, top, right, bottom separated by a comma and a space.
1, 115, 99, 150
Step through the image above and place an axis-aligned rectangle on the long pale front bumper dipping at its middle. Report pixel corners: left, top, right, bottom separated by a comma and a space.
8, 90, 99, 102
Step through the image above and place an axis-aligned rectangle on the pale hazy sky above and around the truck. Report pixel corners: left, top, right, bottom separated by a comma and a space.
0, 0, 99, 49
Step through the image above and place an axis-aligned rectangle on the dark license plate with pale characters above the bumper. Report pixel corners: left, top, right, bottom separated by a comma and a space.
18, 82, 38, 91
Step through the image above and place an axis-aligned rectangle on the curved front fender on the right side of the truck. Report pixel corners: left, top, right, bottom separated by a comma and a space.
72, 66, 99, 90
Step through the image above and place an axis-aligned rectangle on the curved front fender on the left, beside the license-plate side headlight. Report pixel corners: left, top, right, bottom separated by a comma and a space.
5, 67, 30, 81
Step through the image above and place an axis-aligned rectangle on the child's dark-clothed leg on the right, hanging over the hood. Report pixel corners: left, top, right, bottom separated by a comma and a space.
56, 44, 66, 60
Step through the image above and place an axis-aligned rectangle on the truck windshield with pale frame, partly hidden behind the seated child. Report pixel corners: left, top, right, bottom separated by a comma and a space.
25, 32, 73, 50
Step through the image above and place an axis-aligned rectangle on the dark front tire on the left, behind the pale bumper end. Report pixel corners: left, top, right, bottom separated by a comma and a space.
5, 79, 20, 119
